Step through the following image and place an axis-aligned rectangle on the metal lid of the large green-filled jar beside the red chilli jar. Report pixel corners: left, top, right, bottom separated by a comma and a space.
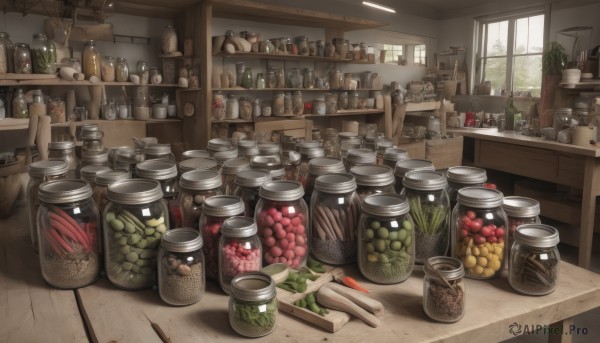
106, 179, 163, 205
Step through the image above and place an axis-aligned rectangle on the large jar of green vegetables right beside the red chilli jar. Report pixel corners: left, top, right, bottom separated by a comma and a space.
103, 179, 169, 290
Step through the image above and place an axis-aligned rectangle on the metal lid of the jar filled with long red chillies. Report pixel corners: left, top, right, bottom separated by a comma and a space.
38, 179, 94, 204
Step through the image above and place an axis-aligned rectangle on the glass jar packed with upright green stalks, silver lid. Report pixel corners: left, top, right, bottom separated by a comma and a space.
401, 170, 451, 265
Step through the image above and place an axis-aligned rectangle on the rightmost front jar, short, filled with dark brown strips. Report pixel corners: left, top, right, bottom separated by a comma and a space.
508, 224, 560, 295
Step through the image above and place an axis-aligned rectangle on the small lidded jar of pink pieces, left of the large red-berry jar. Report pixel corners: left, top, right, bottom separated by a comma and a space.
219, 217, 262, 294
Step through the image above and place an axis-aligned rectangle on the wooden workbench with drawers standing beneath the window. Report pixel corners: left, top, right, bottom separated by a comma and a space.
448, 128, 600, 268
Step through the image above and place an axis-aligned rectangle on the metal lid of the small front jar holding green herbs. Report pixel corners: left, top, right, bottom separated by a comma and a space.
231, 272, 277, 301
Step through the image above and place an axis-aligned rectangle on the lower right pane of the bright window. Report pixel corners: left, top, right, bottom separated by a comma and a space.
512, 55, 542, 96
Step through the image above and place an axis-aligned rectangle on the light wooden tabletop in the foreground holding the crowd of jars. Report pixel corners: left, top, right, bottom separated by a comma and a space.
0, 203, 600, 343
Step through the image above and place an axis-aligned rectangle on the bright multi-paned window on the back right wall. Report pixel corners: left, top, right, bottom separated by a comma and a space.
477, 11, 544, 96
